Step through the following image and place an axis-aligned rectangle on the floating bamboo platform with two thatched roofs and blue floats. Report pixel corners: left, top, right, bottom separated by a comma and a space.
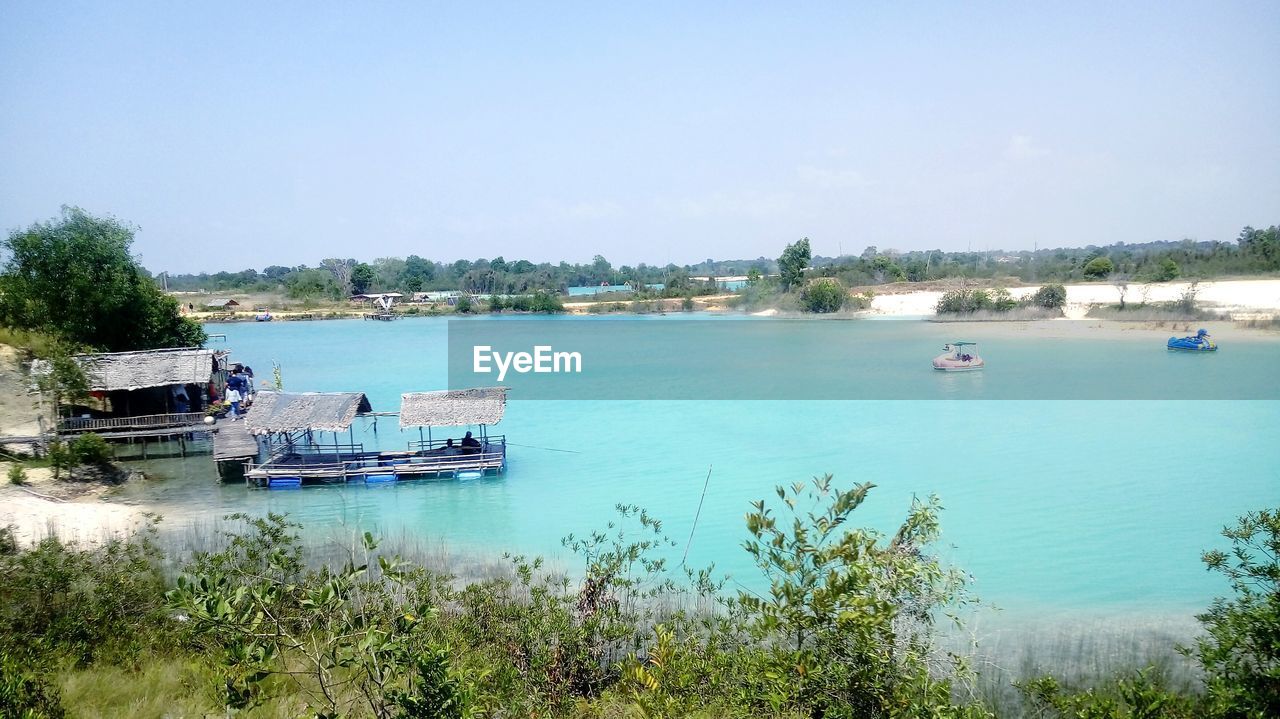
244, 388, 507, 489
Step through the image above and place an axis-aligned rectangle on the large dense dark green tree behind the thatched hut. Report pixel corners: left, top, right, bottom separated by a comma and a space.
0, 207, 206, 352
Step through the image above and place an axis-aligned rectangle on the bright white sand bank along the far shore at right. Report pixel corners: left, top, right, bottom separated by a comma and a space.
870, 280, 1280, 320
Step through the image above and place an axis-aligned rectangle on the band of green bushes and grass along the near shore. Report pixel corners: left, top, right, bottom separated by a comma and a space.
0, 491, 1280, 719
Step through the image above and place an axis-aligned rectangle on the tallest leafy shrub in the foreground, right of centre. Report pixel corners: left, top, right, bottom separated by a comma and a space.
739, 475, 969, 716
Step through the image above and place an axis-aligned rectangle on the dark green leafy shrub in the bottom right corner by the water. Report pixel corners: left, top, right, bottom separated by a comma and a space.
1194, 509, 1280, 718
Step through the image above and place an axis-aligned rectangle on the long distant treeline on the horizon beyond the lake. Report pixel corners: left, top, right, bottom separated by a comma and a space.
165, 221, 1280, 294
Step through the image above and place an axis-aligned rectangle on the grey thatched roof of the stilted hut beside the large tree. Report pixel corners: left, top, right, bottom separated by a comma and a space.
67, 349, 228, 391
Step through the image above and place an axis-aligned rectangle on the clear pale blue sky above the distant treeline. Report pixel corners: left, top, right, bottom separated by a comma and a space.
0, 0, 1280, 273
